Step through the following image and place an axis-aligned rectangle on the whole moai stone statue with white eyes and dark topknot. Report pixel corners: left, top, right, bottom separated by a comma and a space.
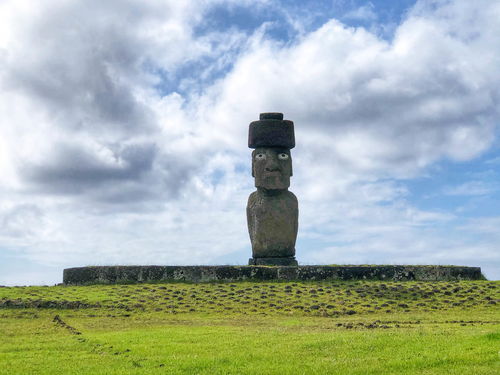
247, 113, 299, 266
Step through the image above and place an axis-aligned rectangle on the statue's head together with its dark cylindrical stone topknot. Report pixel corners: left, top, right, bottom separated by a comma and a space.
248, 112, 295, 190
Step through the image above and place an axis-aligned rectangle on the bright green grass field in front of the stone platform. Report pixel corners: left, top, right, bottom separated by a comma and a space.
0, 281, 500, 374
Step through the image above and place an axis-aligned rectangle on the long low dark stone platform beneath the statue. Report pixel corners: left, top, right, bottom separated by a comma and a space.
63, 265, 484, 285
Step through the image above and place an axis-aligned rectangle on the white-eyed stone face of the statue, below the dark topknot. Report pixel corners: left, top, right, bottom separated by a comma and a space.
252, 147, 292, 190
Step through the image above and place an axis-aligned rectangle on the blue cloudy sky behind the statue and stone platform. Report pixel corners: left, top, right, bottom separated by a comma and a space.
0, 0, 500, 285
